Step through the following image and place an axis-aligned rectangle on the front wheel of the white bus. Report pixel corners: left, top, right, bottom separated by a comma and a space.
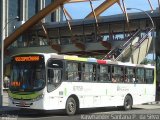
66, 97, 78, 115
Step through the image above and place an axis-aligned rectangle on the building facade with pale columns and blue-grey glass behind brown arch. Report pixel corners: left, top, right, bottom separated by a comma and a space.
0, 0, 63, 39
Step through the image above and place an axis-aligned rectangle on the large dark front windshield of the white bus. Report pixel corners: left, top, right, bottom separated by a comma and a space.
10, 58, 45, 91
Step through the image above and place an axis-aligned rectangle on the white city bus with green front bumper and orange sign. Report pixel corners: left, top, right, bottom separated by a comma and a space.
8, 53, 156, 115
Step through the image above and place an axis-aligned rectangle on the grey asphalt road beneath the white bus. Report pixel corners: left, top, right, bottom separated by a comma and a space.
0, 105, 160, 120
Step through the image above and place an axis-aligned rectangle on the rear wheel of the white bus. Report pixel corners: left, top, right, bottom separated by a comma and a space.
123, 95, 133, 110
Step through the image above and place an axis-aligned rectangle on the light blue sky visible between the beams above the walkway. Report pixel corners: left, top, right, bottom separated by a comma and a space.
65, 0, 158, 19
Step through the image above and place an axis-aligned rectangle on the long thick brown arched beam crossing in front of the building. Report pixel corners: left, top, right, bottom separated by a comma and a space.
4, 0, 70, 49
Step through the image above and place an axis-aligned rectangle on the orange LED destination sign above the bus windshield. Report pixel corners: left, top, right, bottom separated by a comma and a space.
15, 56, 40, 62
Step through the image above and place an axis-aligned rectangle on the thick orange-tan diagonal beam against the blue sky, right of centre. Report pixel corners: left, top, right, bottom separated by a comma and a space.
86, 0, 119, 18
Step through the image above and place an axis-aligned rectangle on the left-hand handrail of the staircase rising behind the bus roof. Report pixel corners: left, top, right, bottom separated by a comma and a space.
103, 29, 141, 60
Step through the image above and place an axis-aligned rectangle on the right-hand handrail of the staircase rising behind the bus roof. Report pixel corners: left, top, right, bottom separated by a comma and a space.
115, 28, 154, 61
